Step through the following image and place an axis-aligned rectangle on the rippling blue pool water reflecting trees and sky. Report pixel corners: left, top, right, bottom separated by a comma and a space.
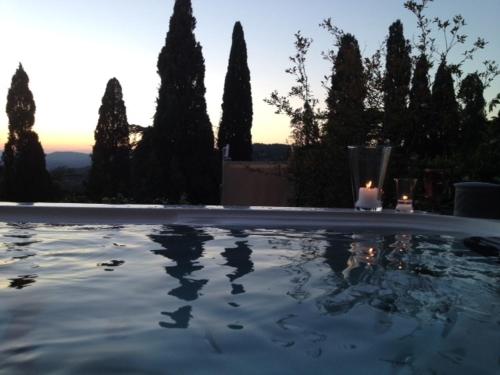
0, 223, 500, 374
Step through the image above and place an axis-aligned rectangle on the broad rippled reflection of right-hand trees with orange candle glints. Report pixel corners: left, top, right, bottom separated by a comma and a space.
318, 233, 468, 336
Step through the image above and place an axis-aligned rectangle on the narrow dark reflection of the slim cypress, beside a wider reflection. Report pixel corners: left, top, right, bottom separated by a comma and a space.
221, 230, 254, 294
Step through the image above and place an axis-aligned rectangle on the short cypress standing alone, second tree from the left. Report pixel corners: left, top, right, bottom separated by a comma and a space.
88, 78, 130, 200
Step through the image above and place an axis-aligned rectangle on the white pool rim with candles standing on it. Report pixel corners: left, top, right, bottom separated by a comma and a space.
0, 202, 500, 236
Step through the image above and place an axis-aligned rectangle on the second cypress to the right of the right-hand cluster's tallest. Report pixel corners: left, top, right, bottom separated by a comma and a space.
431, 60, 460, 158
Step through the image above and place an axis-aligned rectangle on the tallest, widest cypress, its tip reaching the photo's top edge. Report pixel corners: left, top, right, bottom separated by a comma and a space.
152, 0, 217, 204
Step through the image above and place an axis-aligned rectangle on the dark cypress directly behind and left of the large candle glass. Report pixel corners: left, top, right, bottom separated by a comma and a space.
322, 34, 368, 207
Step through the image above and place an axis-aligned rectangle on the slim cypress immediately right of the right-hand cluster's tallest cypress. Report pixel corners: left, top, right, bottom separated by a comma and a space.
405, 54, 432, 159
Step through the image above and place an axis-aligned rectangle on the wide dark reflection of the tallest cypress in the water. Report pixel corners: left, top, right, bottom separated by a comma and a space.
150, 225, 213, 328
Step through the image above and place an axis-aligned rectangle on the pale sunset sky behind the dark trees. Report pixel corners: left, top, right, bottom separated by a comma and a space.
0, 0, 500, 152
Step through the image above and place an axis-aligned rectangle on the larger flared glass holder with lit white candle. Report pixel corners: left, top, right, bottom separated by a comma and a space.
348, 146, 391, 212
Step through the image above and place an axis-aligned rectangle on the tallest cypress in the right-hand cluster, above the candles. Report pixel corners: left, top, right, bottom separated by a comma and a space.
383, 20, 411, 146
